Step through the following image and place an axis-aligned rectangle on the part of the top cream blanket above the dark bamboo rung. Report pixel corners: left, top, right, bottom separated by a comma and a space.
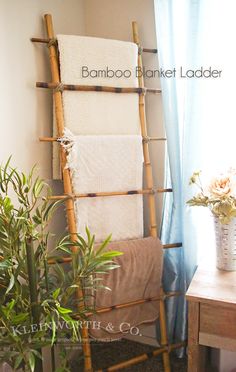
57, 35, 138, 87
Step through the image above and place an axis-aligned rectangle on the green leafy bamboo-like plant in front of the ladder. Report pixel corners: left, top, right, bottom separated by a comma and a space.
0, 159, 122, 371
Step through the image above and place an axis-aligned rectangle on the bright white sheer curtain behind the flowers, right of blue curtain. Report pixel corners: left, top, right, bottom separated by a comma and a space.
188, 0, 236, 263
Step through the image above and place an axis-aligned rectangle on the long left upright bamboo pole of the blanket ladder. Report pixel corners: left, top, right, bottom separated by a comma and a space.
44, 14, 92, 372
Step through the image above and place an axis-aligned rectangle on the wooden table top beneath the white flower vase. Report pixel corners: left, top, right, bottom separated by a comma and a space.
186, 265, 236, 309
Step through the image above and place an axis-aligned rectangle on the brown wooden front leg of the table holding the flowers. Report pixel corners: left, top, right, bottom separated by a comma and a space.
188, 301, 206, 372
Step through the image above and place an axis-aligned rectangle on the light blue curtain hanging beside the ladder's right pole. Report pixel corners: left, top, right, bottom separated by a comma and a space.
155, 0, 202, 348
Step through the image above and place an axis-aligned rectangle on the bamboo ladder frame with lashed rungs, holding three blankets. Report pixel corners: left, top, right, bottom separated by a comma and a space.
31, 14, 185, 372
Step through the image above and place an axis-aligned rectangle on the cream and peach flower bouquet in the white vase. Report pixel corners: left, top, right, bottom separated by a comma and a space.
187, 168, 236, 224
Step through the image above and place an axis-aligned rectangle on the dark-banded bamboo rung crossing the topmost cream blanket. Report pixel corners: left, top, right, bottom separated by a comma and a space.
36, 81, 161, 94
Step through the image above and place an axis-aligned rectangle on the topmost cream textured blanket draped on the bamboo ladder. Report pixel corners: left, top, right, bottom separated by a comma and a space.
57, 35, 140, 135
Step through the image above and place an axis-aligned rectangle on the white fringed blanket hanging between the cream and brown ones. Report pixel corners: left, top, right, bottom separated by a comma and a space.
63, 131, 143, 242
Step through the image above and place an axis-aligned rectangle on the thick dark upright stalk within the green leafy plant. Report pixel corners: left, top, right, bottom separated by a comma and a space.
26, 238, 43, 372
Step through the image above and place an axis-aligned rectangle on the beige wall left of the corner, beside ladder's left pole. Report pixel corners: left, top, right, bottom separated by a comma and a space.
0, 0, 84, 178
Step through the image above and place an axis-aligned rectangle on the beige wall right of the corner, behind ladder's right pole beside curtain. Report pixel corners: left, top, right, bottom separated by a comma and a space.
85, 0, 164, 232
